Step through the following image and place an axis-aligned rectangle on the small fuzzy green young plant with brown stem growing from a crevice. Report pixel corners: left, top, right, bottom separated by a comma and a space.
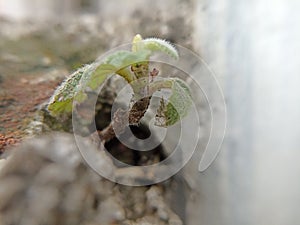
47, 34, 192, 141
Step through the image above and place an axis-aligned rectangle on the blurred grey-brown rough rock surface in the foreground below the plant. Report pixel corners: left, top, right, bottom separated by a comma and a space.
0, 133, 182, 225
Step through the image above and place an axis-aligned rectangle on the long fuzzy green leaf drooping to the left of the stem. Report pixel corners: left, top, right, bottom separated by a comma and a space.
47, 50, 150, 116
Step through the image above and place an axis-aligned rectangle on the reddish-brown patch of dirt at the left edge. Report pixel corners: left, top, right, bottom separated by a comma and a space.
0, 74, 60, 152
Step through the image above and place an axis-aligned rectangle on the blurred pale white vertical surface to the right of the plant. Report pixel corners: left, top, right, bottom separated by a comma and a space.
196, 0, 300, 225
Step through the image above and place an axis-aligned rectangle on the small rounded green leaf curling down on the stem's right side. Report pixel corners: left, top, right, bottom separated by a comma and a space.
152, 78, 192, 127
